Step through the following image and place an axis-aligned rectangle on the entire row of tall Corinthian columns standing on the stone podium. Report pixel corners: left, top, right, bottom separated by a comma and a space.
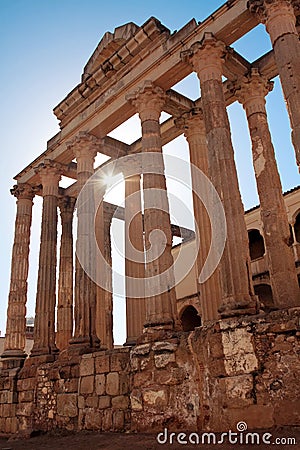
4, 0, 300, 357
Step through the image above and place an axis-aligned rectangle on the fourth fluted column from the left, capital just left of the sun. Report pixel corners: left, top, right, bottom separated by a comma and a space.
67, 132, 102, 352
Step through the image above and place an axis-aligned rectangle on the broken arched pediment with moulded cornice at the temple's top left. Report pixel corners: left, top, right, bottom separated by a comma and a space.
54, 17, 170, 127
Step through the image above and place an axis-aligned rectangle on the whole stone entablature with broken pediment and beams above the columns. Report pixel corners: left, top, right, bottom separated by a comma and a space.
15, 0, 286, 189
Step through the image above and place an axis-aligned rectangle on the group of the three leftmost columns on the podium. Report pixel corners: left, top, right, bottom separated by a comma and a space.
3, 174, 75, 358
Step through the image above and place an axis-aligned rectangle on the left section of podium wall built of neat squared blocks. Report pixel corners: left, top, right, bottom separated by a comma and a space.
0, 347, 130, 435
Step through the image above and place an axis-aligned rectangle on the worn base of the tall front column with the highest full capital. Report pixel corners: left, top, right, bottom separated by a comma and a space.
218, 295, 259, 319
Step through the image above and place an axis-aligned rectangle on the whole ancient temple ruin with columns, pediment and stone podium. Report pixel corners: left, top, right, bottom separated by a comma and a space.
0, 0, 300, 435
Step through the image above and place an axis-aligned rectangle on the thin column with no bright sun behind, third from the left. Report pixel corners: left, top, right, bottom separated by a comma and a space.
56, 197, 76, 351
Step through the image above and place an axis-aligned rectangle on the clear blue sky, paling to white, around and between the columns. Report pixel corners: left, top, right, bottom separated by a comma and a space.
0, 0, 299, 343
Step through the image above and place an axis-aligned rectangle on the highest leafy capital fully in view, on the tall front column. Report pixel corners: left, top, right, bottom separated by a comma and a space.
181, 32, 226, 81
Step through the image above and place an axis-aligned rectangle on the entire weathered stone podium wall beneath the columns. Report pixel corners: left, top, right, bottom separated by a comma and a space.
0, 308, 300, 434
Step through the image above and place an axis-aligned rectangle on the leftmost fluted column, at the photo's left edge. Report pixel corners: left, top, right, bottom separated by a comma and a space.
1, 184, 35, 359
